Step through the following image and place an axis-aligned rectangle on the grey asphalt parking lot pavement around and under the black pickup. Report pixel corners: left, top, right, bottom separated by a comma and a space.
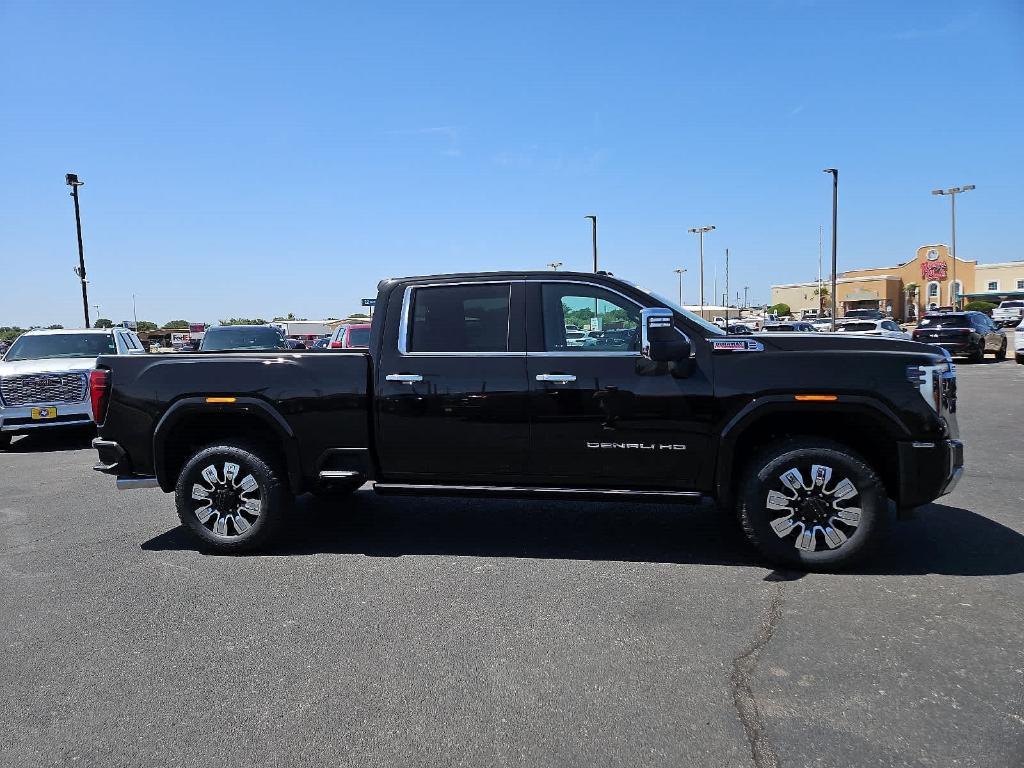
0, 361, 1024, 768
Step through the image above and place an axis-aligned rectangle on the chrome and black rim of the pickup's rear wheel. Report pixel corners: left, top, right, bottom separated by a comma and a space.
191, 462, 262, 539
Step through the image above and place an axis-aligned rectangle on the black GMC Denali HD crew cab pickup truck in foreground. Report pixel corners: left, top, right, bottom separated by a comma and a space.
91, 272, 963, 568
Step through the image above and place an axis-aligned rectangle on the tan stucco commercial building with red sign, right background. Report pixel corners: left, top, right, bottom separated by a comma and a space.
771, 245, 1024, 319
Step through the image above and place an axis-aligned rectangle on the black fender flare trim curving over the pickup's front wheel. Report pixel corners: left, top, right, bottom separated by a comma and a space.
715, 393, 910, 507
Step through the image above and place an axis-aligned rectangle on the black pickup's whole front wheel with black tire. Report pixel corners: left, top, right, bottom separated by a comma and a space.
736, 437, 889, 570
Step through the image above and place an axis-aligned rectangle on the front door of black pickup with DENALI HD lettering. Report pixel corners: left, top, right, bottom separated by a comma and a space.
526, 281, 712, 488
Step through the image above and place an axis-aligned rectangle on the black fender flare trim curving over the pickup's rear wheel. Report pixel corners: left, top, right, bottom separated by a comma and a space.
153, 397, 302, 494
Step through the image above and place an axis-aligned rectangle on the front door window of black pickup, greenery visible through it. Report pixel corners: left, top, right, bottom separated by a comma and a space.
541, 283, 640, 352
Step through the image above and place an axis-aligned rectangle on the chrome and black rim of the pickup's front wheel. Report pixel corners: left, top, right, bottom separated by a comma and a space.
765, 464, 861, 552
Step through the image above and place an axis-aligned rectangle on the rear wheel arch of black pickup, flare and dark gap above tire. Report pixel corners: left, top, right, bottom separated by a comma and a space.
153, 397, 302, 494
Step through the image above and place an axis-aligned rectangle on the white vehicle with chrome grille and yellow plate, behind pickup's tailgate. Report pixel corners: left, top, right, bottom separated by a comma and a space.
0, 328, 145, 450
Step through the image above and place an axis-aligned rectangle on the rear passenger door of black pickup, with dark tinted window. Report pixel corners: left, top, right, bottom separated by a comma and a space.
375, 281, 529, 484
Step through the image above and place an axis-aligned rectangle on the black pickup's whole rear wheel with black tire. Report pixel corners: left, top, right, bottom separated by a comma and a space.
174, 442, 292, 554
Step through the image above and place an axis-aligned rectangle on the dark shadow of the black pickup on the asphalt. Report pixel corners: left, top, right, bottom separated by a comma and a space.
142, 492, 1024, 579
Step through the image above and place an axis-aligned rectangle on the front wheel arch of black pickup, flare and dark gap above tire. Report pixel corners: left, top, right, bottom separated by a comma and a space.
715, 394, 909, 508
